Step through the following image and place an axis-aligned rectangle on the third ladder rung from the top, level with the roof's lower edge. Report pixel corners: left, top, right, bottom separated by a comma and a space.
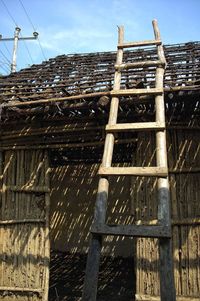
110, 88, 163, 96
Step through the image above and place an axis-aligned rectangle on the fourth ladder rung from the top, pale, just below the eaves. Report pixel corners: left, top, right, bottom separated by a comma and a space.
106, 122, 165, 132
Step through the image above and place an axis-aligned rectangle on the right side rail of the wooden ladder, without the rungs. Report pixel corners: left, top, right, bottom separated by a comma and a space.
153, 20, 176, 301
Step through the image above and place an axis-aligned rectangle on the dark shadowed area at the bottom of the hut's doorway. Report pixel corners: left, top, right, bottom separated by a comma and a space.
49, 252, 135, 301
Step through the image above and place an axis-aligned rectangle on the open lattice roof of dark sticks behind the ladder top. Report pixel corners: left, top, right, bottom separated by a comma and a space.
0, 42, 200, 120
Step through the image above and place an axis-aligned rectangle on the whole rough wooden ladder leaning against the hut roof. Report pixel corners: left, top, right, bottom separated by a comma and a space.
82, 20, 176, 301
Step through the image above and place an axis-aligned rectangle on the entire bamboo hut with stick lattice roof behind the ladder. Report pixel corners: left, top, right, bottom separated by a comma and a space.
0, 42, 200, 301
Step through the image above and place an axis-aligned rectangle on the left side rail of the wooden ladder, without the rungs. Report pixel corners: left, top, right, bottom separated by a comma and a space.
82, 26, 124, 301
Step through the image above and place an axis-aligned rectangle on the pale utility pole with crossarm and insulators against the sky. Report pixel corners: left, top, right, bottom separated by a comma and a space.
0, 27, 38, 73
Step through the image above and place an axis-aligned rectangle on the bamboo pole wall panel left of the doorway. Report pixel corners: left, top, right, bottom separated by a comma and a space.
0, 150, 49, 301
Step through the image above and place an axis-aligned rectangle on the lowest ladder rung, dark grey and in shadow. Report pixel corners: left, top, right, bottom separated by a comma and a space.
91, 224, 171, 238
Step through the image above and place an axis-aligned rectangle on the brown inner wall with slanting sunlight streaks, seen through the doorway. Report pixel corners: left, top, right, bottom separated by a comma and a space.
50, 163, 136, 257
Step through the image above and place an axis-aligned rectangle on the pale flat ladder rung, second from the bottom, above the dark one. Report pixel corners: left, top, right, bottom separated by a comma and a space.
98, 166, 168, 177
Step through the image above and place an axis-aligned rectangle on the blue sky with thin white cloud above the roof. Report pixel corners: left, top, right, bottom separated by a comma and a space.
0, 0, 200, 74
